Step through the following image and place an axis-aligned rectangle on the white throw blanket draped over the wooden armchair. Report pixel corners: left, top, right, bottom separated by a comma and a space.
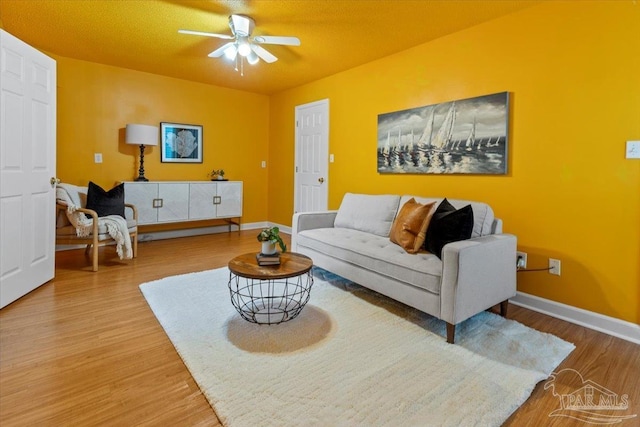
56, 184, 133, 259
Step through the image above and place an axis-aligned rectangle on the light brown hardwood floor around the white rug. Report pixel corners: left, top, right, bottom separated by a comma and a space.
0, 230, 640, 427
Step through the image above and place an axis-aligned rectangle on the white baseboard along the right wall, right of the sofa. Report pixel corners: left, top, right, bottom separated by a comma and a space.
509, 292, 640, 344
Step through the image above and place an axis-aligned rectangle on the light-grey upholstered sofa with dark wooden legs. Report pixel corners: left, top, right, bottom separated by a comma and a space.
291, 193, 516, 343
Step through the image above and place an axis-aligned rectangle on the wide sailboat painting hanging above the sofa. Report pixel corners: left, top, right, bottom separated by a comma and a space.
378, 92, 509, 175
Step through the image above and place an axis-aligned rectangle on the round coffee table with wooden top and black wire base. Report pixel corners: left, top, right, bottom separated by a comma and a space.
229, 252, 313, 325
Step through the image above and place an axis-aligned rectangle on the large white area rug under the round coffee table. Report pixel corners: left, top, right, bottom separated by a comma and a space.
140, 268, 574, 427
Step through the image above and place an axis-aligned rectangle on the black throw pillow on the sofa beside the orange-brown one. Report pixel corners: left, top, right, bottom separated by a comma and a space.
424, 199, 473, 259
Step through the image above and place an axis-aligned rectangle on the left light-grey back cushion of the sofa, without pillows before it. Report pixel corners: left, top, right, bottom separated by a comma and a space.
333, 193, 400, 238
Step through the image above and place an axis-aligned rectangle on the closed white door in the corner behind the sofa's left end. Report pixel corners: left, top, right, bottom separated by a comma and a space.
294, 99, 329, 212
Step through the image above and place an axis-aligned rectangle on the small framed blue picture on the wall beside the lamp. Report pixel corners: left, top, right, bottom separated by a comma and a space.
160, 122, 202, 163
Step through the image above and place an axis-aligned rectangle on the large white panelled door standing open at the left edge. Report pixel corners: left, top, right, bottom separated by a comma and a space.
0, 30, 56, 308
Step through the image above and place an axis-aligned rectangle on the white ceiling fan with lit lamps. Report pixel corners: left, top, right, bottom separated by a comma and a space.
178, 15, 300, 71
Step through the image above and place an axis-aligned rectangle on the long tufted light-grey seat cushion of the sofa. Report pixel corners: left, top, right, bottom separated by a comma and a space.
296, 228, 442, 295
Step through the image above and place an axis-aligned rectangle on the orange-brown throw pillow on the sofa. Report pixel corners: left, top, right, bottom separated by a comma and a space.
389, 198, 436, 254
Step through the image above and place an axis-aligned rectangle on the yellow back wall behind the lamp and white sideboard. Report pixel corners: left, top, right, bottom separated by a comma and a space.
52, 55, 269, 226
